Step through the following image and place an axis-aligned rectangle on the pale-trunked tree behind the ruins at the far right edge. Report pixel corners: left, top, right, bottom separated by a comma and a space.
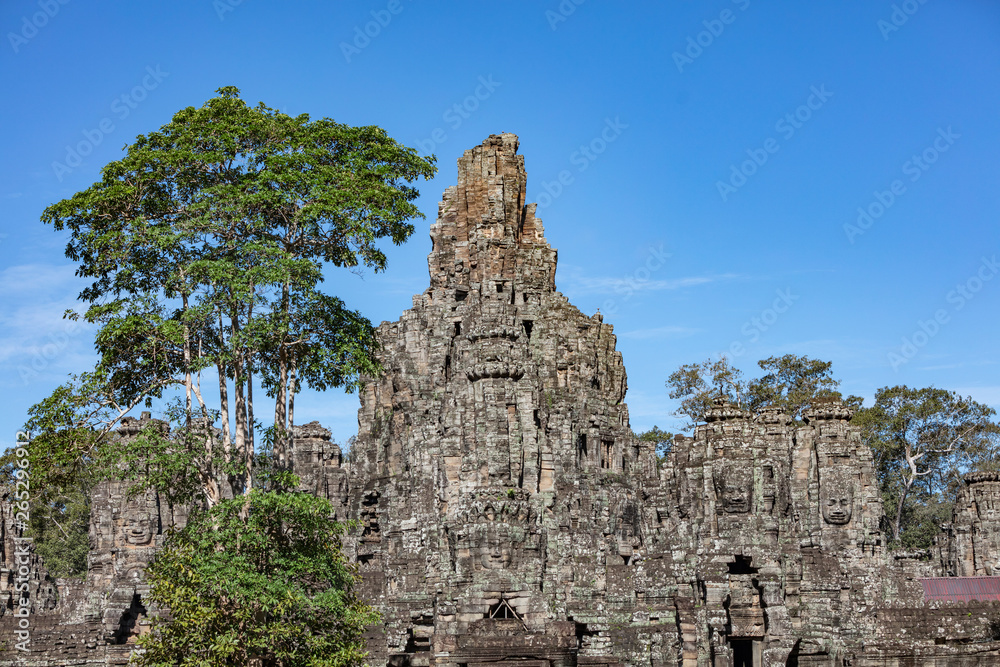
853, 385, 1000, 549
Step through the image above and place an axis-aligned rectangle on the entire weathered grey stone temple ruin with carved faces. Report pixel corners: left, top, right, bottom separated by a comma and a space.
0, 134, 1000, 667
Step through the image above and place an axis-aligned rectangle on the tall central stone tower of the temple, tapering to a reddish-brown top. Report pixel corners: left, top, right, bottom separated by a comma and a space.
348, 134, 656, 665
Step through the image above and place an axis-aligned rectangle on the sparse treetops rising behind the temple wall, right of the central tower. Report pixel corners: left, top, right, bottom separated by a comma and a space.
666, 354, 861, 427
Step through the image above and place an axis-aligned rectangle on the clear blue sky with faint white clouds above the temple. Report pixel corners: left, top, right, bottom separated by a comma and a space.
0, 0, 1000, 444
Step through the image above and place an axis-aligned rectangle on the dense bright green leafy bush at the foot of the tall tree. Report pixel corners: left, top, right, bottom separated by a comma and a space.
137, 490, 378, 667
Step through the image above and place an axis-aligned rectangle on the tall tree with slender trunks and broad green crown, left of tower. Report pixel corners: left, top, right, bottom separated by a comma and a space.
29, 87, 435, 504
